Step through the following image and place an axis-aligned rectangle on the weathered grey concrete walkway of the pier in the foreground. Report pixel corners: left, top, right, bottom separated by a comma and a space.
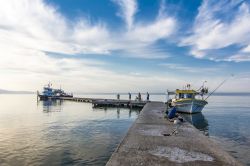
107, 102, 241, 166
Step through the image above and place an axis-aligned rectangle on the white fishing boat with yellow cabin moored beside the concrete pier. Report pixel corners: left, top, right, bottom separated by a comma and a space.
168, 84, 208, 114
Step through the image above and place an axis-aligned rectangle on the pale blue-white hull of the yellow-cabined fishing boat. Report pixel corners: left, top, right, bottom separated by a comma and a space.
173, 100, 207, 114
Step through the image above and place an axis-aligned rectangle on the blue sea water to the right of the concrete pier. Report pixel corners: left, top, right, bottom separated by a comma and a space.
175, 94, 250, 165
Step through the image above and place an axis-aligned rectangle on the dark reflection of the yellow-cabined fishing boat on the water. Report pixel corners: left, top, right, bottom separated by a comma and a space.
181, 113, 208, 135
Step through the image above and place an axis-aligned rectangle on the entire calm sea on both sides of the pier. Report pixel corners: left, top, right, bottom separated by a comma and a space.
0, 94, 250, 166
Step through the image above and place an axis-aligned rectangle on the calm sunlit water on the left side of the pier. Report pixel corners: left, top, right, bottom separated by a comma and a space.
0, 94, 139, 166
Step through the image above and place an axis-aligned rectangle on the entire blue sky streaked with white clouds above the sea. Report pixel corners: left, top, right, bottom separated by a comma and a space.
0, 0, 250, 92
